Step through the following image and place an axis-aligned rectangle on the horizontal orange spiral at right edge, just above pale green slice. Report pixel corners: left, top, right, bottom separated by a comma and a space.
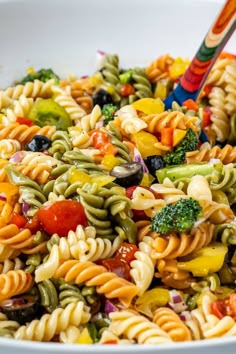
186, 144, 236, 164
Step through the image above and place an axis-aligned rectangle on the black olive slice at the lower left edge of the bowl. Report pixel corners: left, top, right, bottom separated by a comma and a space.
0, 295, 42, 325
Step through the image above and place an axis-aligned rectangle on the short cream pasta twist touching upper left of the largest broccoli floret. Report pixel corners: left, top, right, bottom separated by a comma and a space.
132, 187, 166, 217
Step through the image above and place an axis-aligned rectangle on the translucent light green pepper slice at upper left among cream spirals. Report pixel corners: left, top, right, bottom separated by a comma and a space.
28, 98, 72, 130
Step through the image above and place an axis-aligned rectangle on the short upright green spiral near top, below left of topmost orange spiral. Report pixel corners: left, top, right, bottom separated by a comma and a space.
132, 68, 153, 99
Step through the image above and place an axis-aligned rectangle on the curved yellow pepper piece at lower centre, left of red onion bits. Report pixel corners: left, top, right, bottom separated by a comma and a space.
135, 288, 170, 317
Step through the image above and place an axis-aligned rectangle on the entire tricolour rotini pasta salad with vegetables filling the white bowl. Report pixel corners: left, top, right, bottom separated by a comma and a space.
0, 51, 236, 345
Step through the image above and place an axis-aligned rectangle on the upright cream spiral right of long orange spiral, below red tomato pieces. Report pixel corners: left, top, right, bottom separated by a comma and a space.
130, 251, 154, 296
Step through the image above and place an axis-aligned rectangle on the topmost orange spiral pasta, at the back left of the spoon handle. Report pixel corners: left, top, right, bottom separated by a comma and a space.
145, 54, 174, 83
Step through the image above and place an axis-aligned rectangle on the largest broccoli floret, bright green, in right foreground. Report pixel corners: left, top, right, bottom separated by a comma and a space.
151, 198, 202, 235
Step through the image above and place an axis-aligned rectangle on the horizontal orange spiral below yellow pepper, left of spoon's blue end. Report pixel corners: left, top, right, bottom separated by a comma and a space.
141, 111, 199, 134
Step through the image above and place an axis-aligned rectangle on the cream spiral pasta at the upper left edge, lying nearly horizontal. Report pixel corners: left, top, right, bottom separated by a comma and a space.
0, 79, 55, 99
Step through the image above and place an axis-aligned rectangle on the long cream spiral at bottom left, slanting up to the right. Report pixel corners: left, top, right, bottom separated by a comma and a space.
14, 301, 91, 342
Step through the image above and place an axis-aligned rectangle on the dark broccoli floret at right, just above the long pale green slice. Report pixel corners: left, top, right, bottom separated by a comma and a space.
163, 129, 198, 166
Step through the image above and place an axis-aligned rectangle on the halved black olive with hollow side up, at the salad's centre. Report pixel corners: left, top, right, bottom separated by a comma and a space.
110, 162, 143, 188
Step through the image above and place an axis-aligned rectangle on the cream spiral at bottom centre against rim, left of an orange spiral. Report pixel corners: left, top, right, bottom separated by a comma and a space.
109, 311, 171, 344
